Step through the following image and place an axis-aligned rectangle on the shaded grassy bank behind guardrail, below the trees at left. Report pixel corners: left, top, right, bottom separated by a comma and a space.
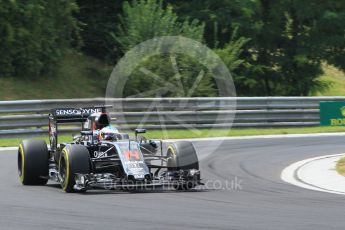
0, 53, 111, 100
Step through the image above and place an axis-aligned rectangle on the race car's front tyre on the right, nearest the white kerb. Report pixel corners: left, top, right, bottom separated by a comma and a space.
167, 141, 199, 190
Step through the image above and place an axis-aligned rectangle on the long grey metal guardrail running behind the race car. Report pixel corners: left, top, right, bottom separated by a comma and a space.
0, 97, 345, 138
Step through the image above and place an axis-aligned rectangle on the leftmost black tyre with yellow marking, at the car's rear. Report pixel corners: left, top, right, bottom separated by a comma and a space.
18, 140, 49, 185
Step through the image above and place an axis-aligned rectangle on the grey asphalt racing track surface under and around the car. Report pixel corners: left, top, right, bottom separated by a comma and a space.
0, 137, 345, 230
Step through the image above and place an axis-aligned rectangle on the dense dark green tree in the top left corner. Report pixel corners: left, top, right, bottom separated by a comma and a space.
0, 0, 78, 77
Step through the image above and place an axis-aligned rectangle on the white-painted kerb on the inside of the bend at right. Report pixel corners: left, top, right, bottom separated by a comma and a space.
281, 153, 345, 195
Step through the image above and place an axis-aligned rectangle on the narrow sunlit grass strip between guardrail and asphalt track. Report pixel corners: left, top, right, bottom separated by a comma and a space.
0, 127, 345, 147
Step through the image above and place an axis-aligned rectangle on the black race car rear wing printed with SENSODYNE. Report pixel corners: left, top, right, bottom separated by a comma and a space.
49, 105, 112, 151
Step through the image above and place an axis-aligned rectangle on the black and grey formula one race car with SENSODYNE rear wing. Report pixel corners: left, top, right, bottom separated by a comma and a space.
18, 106, 202, 192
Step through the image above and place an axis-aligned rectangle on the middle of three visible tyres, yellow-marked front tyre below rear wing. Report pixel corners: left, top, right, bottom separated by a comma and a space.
59, 144, 90, 193
